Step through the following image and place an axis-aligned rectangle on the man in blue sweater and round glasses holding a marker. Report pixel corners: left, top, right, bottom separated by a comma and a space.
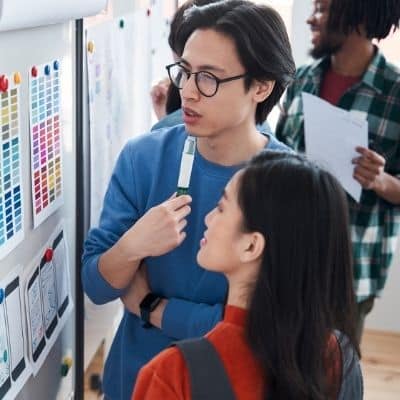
82, 0, 295, 400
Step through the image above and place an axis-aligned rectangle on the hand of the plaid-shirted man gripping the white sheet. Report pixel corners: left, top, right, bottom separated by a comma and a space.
352, 147, 386, 191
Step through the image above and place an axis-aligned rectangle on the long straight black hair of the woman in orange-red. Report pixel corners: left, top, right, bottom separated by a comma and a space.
238, 151, 359, 400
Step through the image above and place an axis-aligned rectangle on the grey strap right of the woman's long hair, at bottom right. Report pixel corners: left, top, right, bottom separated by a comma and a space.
335, 331, 364, 400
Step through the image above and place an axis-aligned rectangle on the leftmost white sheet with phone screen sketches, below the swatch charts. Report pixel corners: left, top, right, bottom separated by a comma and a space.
0, 265, 32, 400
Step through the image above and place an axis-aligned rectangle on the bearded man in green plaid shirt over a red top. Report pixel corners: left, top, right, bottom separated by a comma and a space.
276, 0, 400, 341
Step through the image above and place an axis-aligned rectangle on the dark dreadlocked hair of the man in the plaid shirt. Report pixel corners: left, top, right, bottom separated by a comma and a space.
328, 0, 400, 40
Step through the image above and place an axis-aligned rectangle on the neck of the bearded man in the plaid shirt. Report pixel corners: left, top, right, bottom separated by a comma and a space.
331, 32, 375, 77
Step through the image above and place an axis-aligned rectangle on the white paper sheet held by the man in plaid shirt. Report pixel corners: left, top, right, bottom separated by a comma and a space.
302, 92, 368, 202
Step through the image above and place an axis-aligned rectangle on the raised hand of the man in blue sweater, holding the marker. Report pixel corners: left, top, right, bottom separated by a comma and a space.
119, 194, 192, 260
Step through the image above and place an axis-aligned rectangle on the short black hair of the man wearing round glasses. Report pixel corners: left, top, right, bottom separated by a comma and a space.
177, 0, 296, 123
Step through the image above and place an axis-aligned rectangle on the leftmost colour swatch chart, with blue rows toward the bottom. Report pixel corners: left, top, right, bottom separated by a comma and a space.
0, 74, 24, 259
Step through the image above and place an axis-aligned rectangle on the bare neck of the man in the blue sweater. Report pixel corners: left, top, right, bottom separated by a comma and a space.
197, 127, 268, 166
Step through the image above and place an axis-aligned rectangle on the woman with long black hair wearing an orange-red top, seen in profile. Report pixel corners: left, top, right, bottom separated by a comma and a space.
132, 151, 362, 400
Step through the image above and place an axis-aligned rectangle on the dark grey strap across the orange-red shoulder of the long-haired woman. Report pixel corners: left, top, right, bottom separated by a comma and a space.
173, 338, 236, 400
